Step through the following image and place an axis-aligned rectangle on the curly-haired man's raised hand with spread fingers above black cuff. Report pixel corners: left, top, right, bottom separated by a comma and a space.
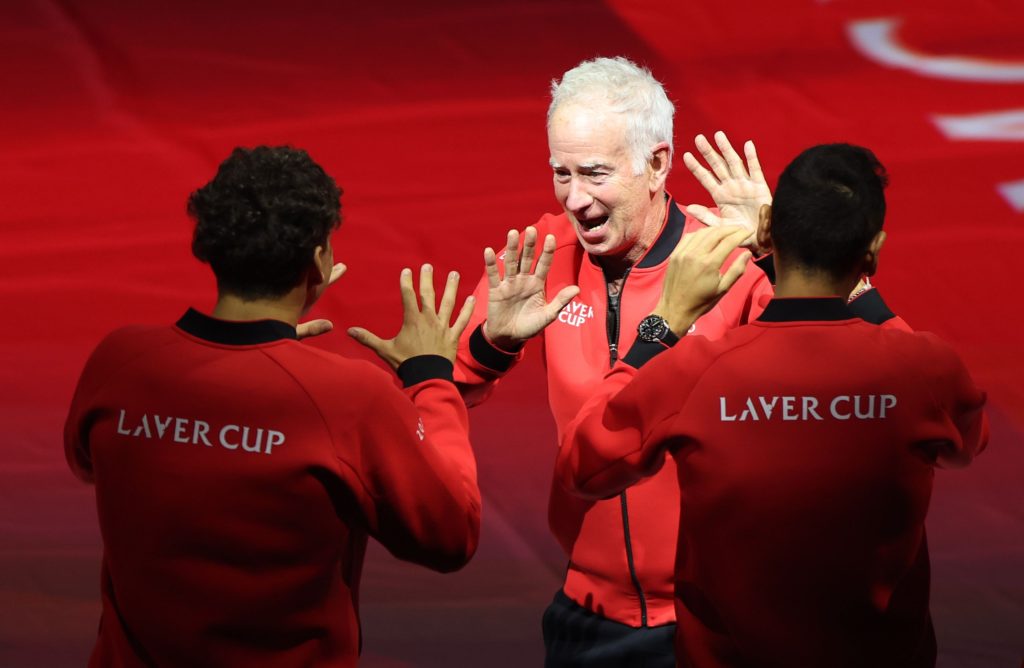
348, 264, 474, 369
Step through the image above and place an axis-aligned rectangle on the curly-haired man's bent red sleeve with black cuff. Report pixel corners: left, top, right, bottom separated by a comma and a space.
341, 356, 480, 572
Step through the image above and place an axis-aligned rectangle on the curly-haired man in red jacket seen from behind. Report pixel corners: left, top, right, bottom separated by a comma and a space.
65, 147, 480, 666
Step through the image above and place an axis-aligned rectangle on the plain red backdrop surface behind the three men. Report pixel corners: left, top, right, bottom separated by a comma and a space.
0, 0, 1024, 667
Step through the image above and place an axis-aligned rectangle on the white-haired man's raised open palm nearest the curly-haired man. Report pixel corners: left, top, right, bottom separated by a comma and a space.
483, 227, 580, 350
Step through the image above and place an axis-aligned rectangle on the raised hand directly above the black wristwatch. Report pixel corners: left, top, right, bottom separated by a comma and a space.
654, 225, 751, 336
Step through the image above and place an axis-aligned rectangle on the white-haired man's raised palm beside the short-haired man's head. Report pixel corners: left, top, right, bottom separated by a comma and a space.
683, 131, 771, 248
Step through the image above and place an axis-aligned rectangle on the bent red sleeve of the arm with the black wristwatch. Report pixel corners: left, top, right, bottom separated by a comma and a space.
555, 337, 707, 499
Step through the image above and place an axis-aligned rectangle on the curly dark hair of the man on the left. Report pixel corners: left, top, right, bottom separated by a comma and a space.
187, 147, 341, 300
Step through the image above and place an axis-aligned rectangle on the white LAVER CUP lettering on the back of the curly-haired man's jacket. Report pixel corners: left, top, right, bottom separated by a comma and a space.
118, 409, 285, 455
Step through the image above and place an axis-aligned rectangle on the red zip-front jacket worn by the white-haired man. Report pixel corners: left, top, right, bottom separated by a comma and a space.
455, 200, 772, 627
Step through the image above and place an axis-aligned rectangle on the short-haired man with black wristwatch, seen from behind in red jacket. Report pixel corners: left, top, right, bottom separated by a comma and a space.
557, 144, 987, 668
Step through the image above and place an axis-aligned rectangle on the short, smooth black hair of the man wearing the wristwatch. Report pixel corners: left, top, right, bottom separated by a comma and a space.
771, 143, 888, 277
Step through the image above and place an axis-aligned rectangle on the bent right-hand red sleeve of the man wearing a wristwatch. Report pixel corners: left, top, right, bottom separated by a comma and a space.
916, 333, 988, 468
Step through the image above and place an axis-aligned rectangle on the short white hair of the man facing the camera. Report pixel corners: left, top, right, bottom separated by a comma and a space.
548, 55, 676, 174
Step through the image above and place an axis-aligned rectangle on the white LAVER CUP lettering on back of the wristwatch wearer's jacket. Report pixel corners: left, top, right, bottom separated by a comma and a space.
719, 394, 897, 422
